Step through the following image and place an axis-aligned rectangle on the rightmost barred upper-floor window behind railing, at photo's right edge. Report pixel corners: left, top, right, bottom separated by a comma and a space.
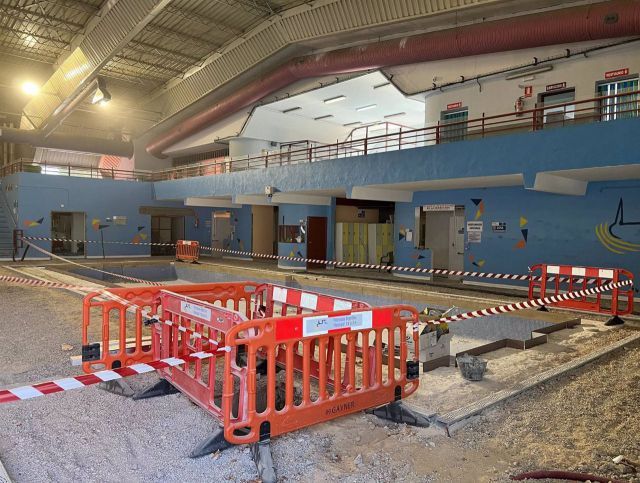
596, 75, 640, 121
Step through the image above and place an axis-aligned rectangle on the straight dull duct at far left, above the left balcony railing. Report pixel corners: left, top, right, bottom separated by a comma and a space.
0, 127, 133, 158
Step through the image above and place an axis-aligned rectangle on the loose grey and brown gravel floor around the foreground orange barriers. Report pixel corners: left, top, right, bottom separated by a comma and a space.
0, 270, 640, 483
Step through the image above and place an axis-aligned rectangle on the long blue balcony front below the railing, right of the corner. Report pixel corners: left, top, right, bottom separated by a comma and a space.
155, 119, 640, 199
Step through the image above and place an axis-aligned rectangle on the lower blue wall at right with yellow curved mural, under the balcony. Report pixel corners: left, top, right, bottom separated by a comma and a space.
396, 181, 640, 276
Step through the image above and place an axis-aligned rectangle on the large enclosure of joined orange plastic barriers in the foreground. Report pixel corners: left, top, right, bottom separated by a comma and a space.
83, 282, 419, 444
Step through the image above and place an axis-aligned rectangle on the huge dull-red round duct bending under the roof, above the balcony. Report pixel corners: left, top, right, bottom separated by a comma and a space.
146, 0, 640, 157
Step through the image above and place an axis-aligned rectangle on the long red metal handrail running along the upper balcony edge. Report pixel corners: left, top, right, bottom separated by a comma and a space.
0, 90, 640, 181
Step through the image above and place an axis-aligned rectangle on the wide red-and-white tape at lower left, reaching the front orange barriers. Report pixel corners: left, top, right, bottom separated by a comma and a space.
0, 347, 231, 404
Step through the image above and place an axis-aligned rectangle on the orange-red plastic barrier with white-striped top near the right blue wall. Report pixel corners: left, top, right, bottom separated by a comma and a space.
529, 264, 633, 316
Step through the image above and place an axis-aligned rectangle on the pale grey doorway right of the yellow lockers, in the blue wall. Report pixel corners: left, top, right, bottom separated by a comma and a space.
421, 206, 464, 278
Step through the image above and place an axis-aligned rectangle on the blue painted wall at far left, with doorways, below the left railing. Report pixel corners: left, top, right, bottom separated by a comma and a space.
13, 173, 211, 257
